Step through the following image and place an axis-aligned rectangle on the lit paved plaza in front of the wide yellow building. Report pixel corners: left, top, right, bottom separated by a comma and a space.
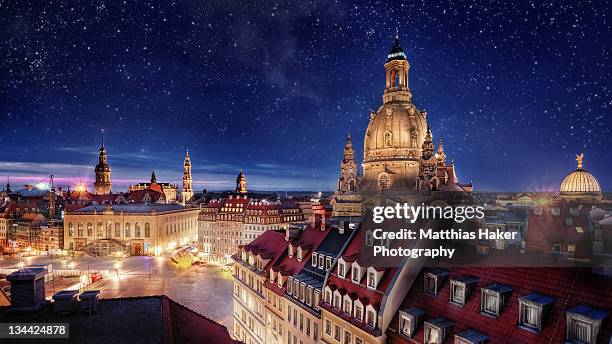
0, 256, 233, 328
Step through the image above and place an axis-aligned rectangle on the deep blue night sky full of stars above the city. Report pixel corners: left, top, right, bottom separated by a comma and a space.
0, 0, 612, 191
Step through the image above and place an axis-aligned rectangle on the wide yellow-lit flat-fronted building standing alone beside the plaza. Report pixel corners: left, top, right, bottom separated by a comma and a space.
64, 203, 199, 256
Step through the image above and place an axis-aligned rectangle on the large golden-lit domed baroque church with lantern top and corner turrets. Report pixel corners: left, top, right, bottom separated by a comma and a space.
332, 34, 472, 216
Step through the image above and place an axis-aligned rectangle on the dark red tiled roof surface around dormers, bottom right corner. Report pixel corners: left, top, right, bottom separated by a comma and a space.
387, 267, 612, 344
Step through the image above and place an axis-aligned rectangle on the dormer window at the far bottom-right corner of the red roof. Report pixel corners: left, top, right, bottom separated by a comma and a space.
565, 305, 608, 344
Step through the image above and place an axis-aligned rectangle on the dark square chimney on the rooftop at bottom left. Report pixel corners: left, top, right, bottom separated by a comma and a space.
6, 268, 47, 312
